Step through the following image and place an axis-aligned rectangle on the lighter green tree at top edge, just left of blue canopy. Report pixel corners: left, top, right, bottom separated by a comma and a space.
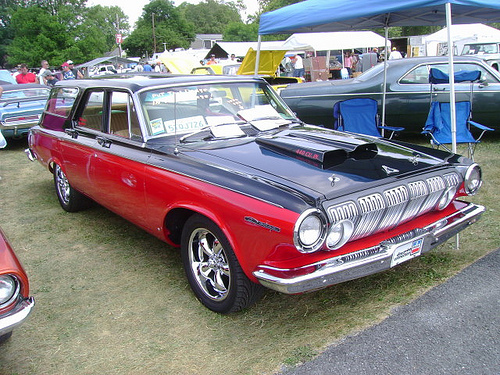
179, 0, 242, 34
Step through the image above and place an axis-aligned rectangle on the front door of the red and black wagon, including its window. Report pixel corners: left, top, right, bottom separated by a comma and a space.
91, 90, 150, 230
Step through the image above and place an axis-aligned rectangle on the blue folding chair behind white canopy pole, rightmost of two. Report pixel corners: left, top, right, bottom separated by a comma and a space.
422, 68, 494, 160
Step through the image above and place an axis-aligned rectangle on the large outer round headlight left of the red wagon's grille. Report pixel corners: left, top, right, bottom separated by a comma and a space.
294, 209, 326, 253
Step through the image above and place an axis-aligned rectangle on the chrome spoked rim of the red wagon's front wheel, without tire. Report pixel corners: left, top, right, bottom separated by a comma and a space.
188, 228, 231, 301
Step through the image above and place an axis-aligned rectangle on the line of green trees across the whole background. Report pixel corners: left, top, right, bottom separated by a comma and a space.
0, 0, 499, 68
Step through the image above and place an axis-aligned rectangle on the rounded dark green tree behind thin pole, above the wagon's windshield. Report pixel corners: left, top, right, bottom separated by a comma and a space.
123, 0, 194, 56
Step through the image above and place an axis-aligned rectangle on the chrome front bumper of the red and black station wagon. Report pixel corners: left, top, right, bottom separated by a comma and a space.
253, 203, 485, 294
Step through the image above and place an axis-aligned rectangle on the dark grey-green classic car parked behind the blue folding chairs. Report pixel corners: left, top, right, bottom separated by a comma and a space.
280, 56, 500, 132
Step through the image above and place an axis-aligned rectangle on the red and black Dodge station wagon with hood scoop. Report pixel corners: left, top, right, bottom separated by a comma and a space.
28, 76, 484, 313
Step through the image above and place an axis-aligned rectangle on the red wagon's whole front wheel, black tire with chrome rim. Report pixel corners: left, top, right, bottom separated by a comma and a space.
181, 215, 263, 314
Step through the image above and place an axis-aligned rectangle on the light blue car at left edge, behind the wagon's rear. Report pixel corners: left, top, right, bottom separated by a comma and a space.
0, 83, 50, 144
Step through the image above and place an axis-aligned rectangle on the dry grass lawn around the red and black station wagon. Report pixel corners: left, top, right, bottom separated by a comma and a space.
0, 136, 500, 375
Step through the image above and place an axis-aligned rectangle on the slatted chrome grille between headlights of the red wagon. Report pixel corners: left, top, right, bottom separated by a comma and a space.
327, 172, 461, 240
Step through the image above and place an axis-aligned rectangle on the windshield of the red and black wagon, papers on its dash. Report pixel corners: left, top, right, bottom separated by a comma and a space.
139, 82, 298, 141
